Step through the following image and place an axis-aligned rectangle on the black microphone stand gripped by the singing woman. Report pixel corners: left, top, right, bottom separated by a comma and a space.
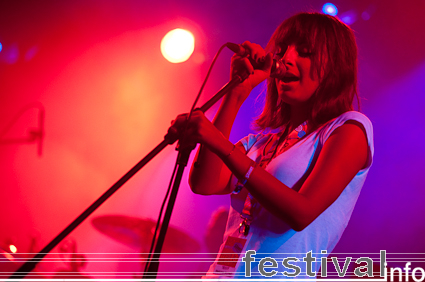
9, 73, 249, 279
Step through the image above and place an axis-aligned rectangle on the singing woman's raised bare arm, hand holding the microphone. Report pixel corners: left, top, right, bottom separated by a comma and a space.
189, 42, 272, 195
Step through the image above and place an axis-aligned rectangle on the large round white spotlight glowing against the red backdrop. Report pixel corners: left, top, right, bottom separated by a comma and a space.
161, 28, 195, 63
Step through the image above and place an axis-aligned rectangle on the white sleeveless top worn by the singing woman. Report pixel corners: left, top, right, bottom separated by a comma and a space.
205, 111, 374, 279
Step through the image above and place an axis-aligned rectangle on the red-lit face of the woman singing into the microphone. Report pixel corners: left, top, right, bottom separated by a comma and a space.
275, 44, 319, 107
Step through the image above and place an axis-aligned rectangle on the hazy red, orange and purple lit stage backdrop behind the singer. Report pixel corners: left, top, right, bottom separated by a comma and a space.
0, 0, 425, 278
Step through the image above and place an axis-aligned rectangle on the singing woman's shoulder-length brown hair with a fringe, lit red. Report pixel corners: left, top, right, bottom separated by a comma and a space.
254, 12, 359, 129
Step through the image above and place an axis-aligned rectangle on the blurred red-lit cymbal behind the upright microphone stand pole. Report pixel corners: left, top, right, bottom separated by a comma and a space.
92, 215, 200, 253
